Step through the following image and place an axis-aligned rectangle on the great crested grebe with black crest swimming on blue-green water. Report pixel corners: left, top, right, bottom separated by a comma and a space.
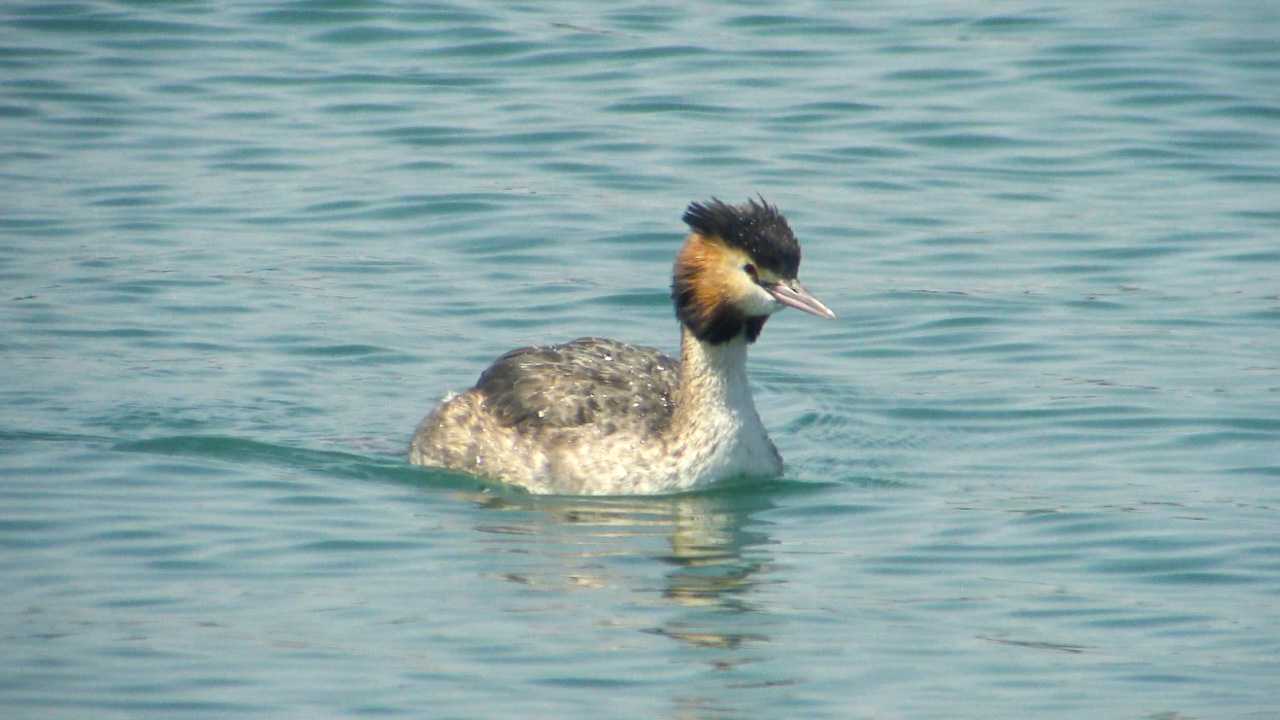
410, 197, 836, 495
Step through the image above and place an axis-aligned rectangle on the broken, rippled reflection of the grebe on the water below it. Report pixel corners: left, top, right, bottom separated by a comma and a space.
474, 486, 773, 648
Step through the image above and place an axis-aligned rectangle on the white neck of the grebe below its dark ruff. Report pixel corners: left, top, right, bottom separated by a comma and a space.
672, 325, 760, 429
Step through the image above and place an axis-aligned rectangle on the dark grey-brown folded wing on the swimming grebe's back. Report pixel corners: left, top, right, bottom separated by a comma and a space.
476, 337, 680, 433
